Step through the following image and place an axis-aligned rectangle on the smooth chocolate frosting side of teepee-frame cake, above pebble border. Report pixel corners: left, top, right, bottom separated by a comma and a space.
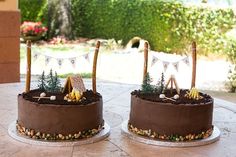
129, 95, 213, 136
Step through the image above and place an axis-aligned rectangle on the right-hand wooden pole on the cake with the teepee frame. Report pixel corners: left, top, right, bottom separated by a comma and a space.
191, 41, 197, 88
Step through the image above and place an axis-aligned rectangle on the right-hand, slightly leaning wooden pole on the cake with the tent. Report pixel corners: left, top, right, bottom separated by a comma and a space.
92, 41, 100, 93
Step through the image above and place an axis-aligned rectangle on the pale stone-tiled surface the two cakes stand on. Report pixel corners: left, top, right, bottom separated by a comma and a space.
0, 80, 236, 157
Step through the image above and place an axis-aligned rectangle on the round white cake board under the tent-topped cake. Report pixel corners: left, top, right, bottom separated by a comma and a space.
8, 121, 110, 147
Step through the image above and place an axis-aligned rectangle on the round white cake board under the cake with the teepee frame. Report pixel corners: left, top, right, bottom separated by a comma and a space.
121, 120, 220, 147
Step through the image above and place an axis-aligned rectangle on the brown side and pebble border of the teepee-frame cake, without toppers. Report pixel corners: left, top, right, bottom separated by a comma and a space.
129, 91, 213, 141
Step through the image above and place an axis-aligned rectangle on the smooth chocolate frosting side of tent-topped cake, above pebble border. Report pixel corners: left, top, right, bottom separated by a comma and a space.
18, 95, 104, 134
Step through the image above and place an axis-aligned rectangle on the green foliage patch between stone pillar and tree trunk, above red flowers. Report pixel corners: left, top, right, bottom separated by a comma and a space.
19, 0, 47, 25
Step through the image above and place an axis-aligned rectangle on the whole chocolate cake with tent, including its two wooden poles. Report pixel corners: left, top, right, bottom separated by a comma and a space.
16, 41, 104, 141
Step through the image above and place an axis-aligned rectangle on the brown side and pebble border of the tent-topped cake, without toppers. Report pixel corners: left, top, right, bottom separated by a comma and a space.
17, 90, 104, 140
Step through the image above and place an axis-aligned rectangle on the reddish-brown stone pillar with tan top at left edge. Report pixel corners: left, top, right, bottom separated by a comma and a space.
0, 0, 20, 83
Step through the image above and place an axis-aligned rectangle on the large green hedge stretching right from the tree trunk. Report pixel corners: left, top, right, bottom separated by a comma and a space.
71, 0, 235, 53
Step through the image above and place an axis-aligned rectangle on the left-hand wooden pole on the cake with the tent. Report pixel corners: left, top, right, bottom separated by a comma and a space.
25, 40, 31, 92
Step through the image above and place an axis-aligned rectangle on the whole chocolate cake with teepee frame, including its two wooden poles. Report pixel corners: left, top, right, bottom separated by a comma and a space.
128, 42, 214, 142
